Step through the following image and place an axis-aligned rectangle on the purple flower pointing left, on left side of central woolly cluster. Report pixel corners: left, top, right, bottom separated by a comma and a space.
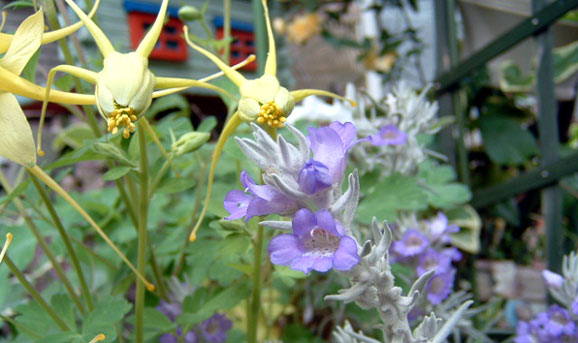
224, 170, 297, 221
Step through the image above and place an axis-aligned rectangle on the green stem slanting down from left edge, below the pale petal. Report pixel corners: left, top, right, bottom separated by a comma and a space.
0, 171, 85, 313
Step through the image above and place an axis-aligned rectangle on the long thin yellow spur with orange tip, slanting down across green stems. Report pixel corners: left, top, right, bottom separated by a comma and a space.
26, 166, 155, 292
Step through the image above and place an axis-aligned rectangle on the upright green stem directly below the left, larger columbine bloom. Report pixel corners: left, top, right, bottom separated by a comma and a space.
135, 125, 149, 343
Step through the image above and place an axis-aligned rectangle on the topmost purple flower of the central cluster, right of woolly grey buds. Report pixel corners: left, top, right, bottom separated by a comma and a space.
308, 122, 360, 184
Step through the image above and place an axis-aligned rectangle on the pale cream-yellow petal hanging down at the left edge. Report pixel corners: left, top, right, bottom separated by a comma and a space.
0, 93, 36, 167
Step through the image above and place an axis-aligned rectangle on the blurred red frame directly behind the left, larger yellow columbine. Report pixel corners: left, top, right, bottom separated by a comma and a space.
128, 12, 189, 61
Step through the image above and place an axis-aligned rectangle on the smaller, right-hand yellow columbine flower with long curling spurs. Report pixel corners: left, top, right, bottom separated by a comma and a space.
184, 0, 355, 241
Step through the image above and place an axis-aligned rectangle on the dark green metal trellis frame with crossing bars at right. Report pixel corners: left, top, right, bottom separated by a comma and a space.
434, 0, 578, 272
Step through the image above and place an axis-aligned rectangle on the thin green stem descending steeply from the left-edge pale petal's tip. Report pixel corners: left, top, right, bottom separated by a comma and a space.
29, 173, 94, 310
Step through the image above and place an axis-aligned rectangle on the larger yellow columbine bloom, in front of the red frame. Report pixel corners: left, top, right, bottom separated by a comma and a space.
38, 0, 229, 146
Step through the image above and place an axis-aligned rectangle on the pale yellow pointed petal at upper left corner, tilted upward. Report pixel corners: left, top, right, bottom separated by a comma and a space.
0, 10, 44, 75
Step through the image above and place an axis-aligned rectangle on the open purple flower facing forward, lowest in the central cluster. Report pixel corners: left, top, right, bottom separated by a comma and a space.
268, 208, 360, 274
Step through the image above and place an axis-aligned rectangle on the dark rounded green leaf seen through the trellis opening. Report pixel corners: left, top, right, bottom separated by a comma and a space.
480, 115, 537, 165
